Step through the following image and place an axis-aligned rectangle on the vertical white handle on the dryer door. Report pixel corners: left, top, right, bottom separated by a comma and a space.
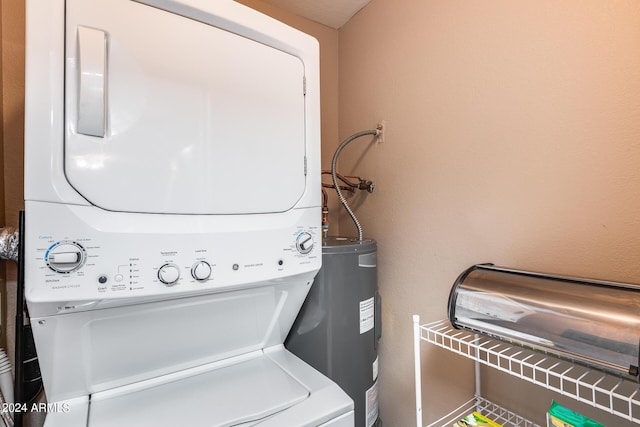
77, 27, 107, 138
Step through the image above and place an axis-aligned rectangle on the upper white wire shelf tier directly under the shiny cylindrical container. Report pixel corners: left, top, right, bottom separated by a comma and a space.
419, 320, 640, 426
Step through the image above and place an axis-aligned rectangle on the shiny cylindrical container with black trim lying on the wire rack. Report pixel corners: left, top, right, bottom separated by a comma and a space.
448, 265, 640, 381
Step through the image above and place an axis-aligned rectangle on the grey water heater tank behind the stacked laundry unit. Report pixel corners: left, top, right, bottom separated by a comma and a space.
285, 237, 382, 427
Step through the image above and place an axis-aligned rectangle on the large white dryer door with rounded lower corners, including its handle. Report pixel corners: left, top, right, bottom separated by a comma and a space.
65, 0, 306, 214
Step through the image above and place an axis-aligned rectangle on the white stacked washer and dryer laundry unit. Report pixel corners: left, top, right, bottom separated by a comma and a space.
25, 0, 353, 427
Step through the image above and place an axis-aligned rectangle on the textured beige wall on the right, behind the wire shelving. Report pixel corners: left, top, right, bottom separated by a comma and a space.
339, 0, 640, 427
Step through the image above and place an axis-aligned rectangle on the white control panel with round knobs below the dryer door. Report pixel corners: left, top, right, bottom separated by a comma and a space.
25, 202, 322, 318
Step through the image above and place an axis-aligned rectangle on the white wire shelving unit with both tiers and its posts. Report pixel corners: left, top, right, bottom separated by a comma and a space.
413, 316, 640, 427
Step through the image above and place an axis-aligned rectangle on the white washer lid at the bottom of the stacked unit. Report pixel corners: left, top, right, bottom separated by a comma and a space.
87, 355, 309, 427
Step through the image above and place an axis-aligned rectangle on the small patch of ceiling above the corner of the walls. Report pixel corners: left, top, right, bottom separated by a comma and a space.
263, 0, 371, 29
